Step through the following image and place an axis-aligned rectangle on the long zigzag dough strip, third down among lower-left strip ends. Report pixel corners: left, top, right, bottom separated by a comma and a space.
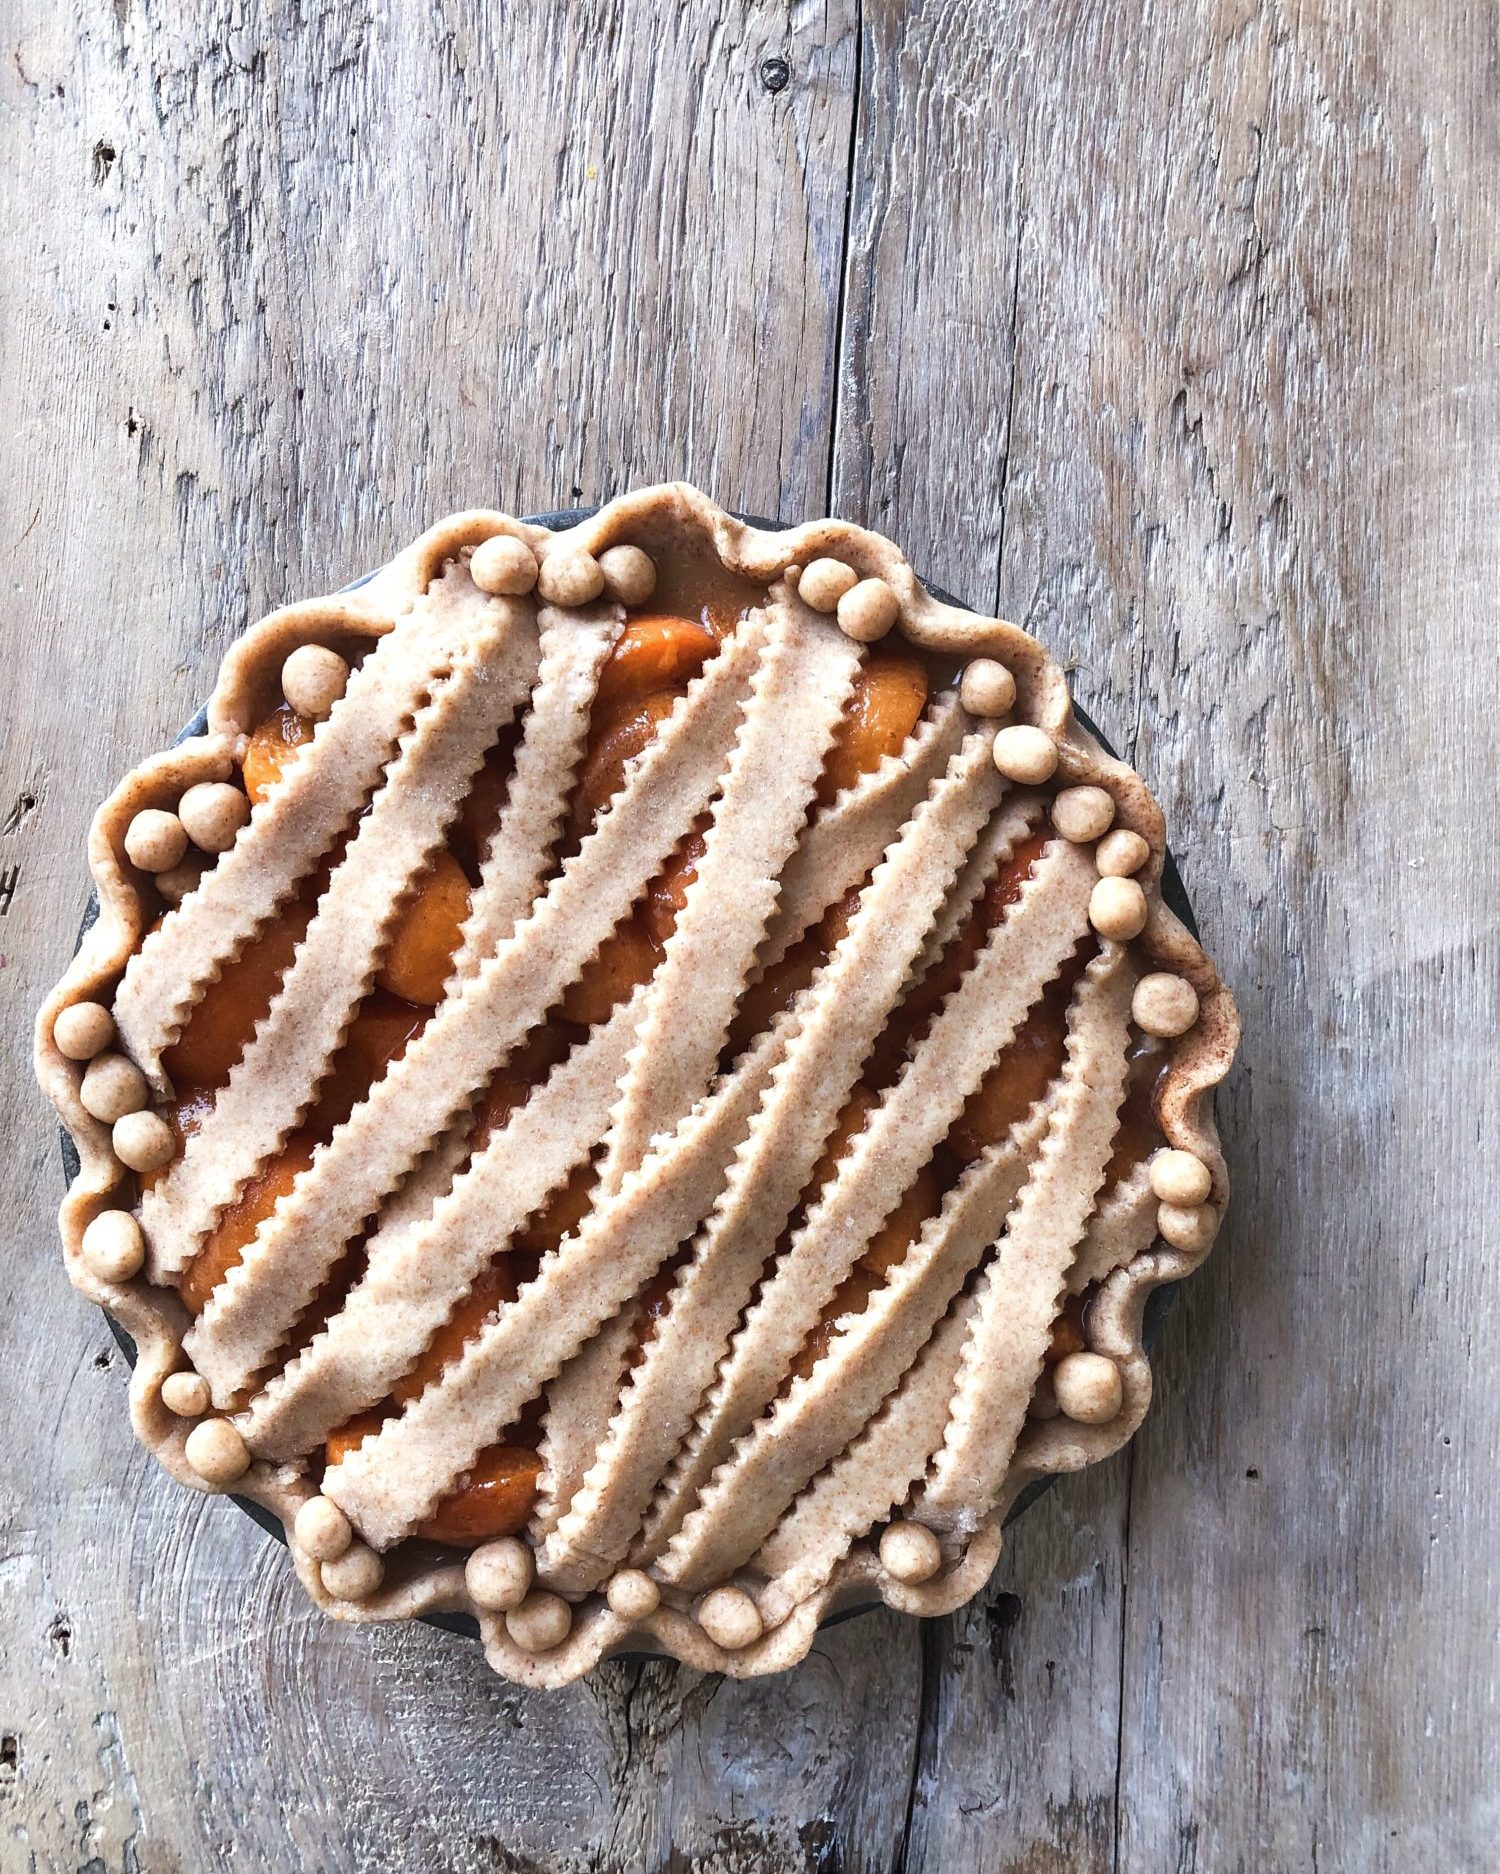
193, 618, 761, 1404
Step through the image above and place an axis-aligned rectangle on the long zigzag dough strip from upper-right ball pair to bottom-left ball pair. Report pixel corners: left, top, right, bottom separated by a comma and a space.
538, 731, 1001, 1580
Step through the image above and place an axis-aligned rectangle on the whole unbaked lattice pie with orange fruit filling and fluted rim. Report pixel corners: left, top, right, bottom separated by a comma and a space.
38, 485, 1238, 1685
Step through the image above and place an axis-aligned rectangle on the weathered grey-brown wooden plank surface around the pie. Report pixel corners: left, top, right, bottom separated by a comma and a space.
0, 0, 1500, 1874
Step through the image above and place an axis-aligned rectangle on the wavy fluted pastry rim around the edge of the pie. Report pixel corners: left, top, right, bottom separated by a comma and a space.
36, 483, 1238, 1685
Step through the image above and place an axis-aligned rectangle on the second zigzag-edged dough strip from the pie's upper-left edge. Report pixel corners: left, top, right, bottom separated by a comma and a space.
141, 602, 536, 1272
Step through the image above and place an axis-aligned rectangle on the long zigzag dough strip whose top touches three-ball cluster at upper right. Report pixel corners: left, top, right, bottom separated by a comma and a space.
648, 832, 1097, 1551
